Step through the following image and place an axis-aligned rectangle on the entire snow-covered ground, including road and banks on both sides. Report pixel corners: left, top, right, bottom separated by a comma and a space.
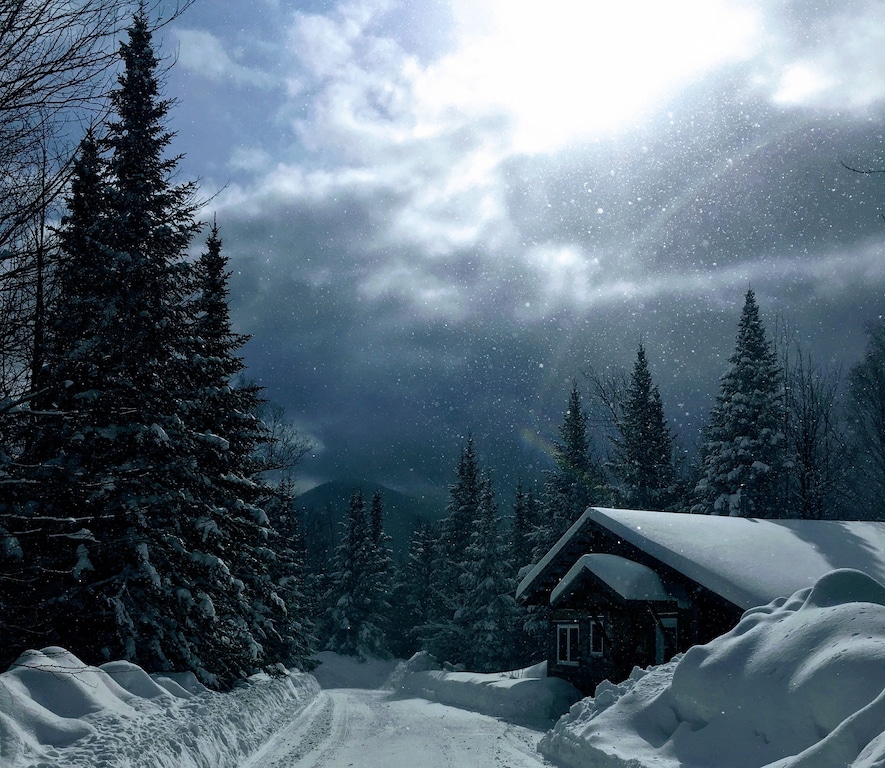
0, 570, 885, 768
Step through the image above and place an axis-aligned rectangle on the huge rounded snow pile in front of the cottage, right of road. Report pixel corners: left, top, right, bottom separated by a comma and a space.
539, 570, 885, 768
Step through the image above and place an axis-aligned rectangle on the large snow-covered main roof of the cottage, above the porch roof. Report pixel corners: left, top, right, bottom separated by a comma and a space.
517, 507, 885, 609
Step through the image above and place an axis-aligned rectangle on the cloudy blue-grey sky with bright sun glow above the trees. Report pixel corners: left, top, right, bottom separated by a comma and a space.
158, 0, 885, 500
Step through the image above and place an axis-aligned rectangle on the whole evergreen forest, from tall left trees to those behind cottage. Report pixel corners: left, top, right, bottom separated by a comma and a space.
0, 2, 885, 688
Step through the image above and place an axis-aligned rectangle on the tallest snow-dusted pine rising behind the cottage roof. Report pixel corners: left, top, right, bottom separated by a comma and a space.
695, 289, 786, 517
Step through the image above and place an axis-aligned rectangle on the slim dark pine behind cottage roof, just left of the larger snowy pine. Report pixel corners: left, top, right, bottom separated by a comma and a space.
612, 342, 676, 509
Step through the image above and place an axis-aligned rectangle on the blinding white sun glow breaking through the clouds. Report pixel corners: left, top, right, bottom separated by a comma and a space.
432, 0, 760, 152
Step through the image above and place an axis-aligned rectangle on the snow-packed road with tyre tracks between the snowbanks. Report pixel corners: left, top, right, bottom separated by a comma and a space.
238, 689, 550, 768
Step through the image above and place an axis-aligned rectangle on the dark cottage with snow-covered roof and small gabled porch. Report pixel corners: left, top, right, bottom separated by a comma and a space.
516, 507, 885, 692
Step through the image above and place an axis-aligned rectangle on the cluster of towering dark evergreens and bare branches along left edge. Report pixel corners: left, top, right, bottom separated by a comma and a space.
0, 7, 313, 688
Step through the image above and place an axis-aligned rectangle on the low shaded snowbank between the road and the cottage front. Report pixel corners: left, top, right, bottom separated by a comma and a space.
389, 653, 581, 724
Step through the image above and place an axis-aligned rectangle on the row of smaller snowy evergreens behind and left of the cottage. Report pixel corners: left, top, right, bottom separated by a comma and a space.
317, 290, 885, 671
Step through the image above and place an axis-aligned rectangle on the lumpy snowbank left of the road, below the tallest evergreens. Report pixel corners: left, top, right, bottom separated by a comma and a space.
0, 648, 319, 768
